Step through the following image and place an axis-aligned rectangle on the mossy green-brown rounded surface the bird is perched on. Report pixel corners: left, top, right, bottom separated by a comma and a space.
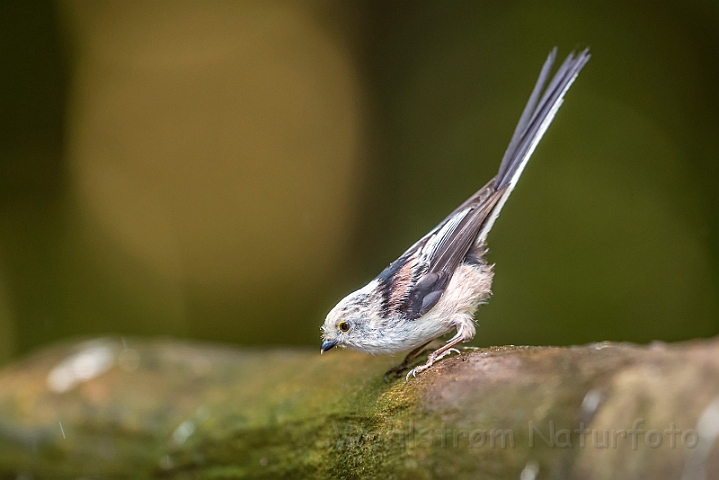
0, 338, 719, 480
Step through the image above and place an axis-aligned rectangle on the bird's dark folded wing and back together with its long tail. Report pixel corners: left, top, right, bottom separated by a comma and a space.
377, 48, 589, 320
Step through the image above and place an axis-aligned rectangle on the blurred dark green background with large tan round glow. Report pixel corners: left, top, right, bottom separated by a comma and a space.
0, 0, 719, 362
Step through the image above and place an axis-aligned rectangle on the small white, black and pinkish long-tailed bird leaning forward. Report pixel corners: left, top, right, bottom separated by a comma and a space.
320, 47, 591, 381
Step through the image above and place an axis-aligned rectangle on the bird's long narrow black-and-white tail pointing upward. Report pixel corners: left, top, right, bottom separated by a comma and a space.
477, 47, 590, 244
